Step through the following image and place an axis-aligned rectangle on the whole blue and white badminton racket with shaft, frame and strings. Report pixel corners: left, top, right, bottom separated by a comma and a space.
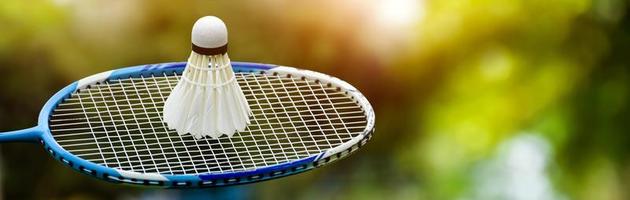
0, 62, 375, 188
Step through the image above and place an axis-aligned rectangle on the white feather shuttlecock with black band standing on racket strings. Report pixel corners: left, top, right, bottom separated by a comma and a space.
163, 16, 251, 139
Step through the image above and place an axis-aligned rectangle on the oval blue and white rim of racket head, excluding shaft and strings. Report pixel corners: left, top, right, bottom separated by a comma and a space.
37, 62, 375, 188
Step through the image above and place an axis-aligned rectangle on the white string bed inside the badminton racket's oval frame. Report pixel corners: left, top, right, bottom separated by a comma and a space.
50, 73, 367, 174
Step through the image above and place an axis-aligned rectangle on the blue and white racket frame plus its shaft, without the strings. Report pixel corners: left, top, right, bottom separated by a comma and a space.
0, 62, 374, 188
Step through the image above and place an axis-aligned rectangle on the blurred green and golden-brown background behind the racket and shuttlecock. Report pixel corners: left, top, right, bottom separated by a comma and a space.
0, 0, 630, 200
